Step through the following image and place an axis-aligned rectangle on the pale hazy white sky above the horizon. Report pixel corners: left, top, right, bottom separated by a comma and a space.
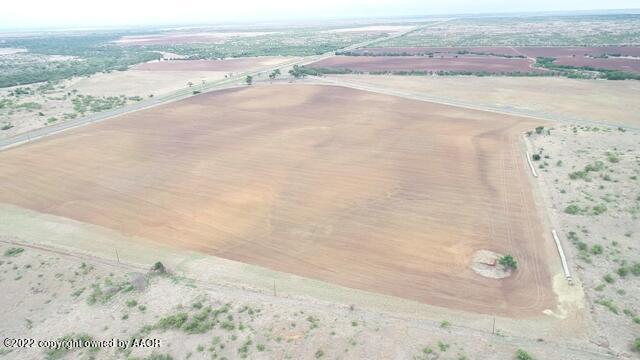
0, 0, 640, 29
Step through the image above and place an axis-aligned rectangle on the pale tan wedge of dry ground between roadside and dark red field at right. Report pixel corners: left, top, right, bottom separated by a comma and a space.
329, 75, 640, 127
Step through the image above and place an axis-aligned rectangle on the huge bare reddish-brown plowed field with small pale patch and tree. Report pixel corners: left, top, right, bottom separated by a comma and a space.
0, 85, 557, 317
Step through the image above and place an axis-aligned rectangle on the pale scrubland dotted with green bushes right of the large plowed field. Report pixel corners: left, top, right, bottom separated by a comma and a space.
528, 124, 640, 358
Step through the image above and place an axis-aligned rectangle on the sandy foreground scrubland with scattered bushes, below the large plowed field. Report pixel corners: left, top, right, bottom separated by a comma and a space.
0, 239, 612, 360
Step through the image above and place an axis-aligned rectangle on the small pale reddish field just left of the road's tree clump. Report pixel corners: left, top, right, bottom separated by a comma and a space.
133, 57, 286, 71
